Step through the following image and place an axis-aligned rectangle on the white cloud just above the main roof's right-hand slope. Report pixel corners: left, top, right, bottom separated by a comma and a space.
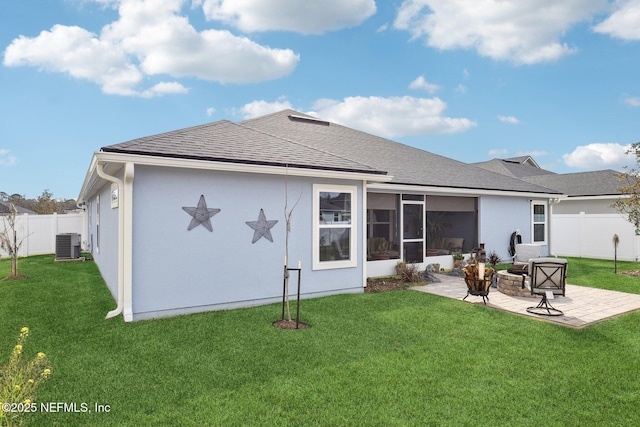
311, 96, 477, 138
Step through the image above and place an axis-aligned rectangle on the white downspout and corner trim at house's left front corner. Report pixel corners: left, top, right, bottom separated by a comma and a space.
96, 160, 133, 322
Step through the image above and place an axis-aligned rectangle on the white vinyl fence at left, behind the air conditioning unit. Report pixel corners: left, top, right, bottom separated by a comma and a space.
0, 213, 87, 257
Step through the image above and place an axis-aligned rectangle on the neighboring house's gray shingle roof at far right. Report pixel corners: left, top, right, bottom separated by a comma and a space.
523, 169, 622, 197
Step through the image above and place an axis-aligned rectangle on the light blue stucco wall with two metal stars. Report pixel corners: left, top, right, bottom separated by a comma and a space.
129, 166, 364, 319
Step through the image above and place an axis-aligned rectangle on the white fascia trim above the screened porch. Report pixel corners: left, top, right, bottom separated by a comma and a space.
367, 183, 567, 199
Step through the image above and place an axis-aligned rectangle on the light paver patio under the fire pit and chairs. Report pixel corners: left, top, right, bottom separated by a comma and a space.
411, 274, 640, 328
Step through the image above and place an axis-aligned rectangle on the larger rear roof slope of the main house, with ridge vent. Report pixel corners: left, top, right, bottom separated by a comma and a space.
240, 110, 558, 194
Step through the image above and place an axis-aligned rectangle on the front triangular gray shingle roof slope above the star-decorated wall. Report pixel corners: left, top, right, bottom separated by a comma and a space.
101, 120, 384, 174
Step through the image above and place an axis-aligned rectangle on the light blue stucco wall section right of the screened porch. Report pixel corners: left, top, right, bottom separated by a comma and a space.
478, 196, 549, 262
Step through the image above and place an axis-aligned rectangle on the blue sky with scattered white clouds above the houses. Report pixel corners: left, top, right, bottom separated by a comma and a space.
0, 0, 640, 198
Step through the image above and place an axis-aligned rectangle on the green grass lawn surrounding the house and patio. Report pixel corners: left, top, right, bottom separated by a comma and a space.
0, 256, 640, 426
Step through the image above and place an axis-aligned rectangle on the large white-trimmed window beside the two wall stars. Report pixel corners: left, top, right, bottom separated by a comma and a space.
313, 184, 358, 270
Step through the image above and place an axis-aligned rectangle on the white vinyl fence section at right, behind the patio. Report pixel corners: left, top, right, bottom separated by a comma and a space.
550, 213, 640, 261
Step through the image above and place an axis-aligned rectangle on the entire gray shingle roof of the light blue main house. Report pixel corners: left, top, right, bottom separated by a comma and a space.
102, 110, 557, 193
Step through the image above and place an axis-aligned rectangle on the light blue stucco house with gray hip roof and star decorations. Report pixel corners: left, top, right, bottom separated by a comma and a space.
78, 110, 564, 321
